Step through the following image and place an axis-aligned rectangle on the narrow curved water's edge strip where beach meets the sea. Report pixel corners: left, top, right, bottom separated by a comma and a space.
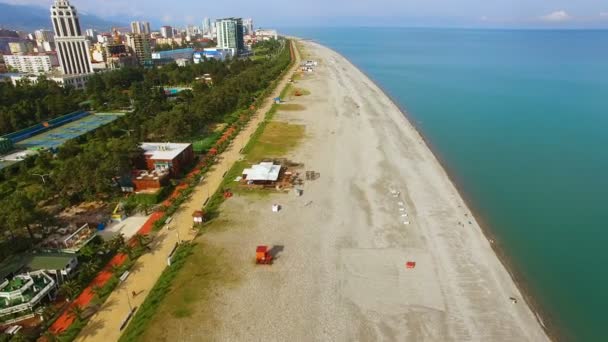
300, 37, 556, 341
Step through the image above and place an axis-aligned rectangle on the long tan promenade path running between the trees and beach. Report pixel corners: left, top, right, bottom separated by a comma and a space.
76, 43, 299, 342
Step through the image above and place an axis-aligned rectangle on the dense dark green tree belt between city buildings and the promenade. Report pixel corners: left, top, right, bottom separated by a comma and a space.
0, 40, 289, 250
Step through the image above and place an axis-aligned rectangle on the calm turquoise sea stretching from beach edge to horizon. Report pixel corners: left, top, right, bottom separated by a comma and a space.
282, 28, 608, 341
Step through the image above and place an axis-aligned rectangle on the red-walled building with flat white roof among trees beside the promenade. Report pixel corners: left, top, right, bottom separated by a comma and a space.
141, 143, 194, 176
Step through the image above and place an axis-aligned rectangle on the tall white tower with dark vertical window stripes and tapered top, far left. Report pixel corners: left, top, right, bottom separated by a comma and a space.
51, 0, 93, 75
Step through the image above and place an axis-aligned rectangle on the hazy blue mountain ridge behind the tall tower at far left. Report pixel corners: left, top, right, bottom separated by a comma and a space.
0, 1, 123, 31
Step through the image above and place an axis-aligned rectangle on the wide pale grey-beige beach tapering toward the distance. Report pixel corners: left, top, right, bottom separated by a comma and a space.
145, 38, 549, 341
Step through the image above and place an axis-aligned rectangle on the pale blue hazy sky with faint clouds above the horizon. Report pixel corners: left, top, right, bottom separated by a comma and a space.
0, 0, 608, 28
